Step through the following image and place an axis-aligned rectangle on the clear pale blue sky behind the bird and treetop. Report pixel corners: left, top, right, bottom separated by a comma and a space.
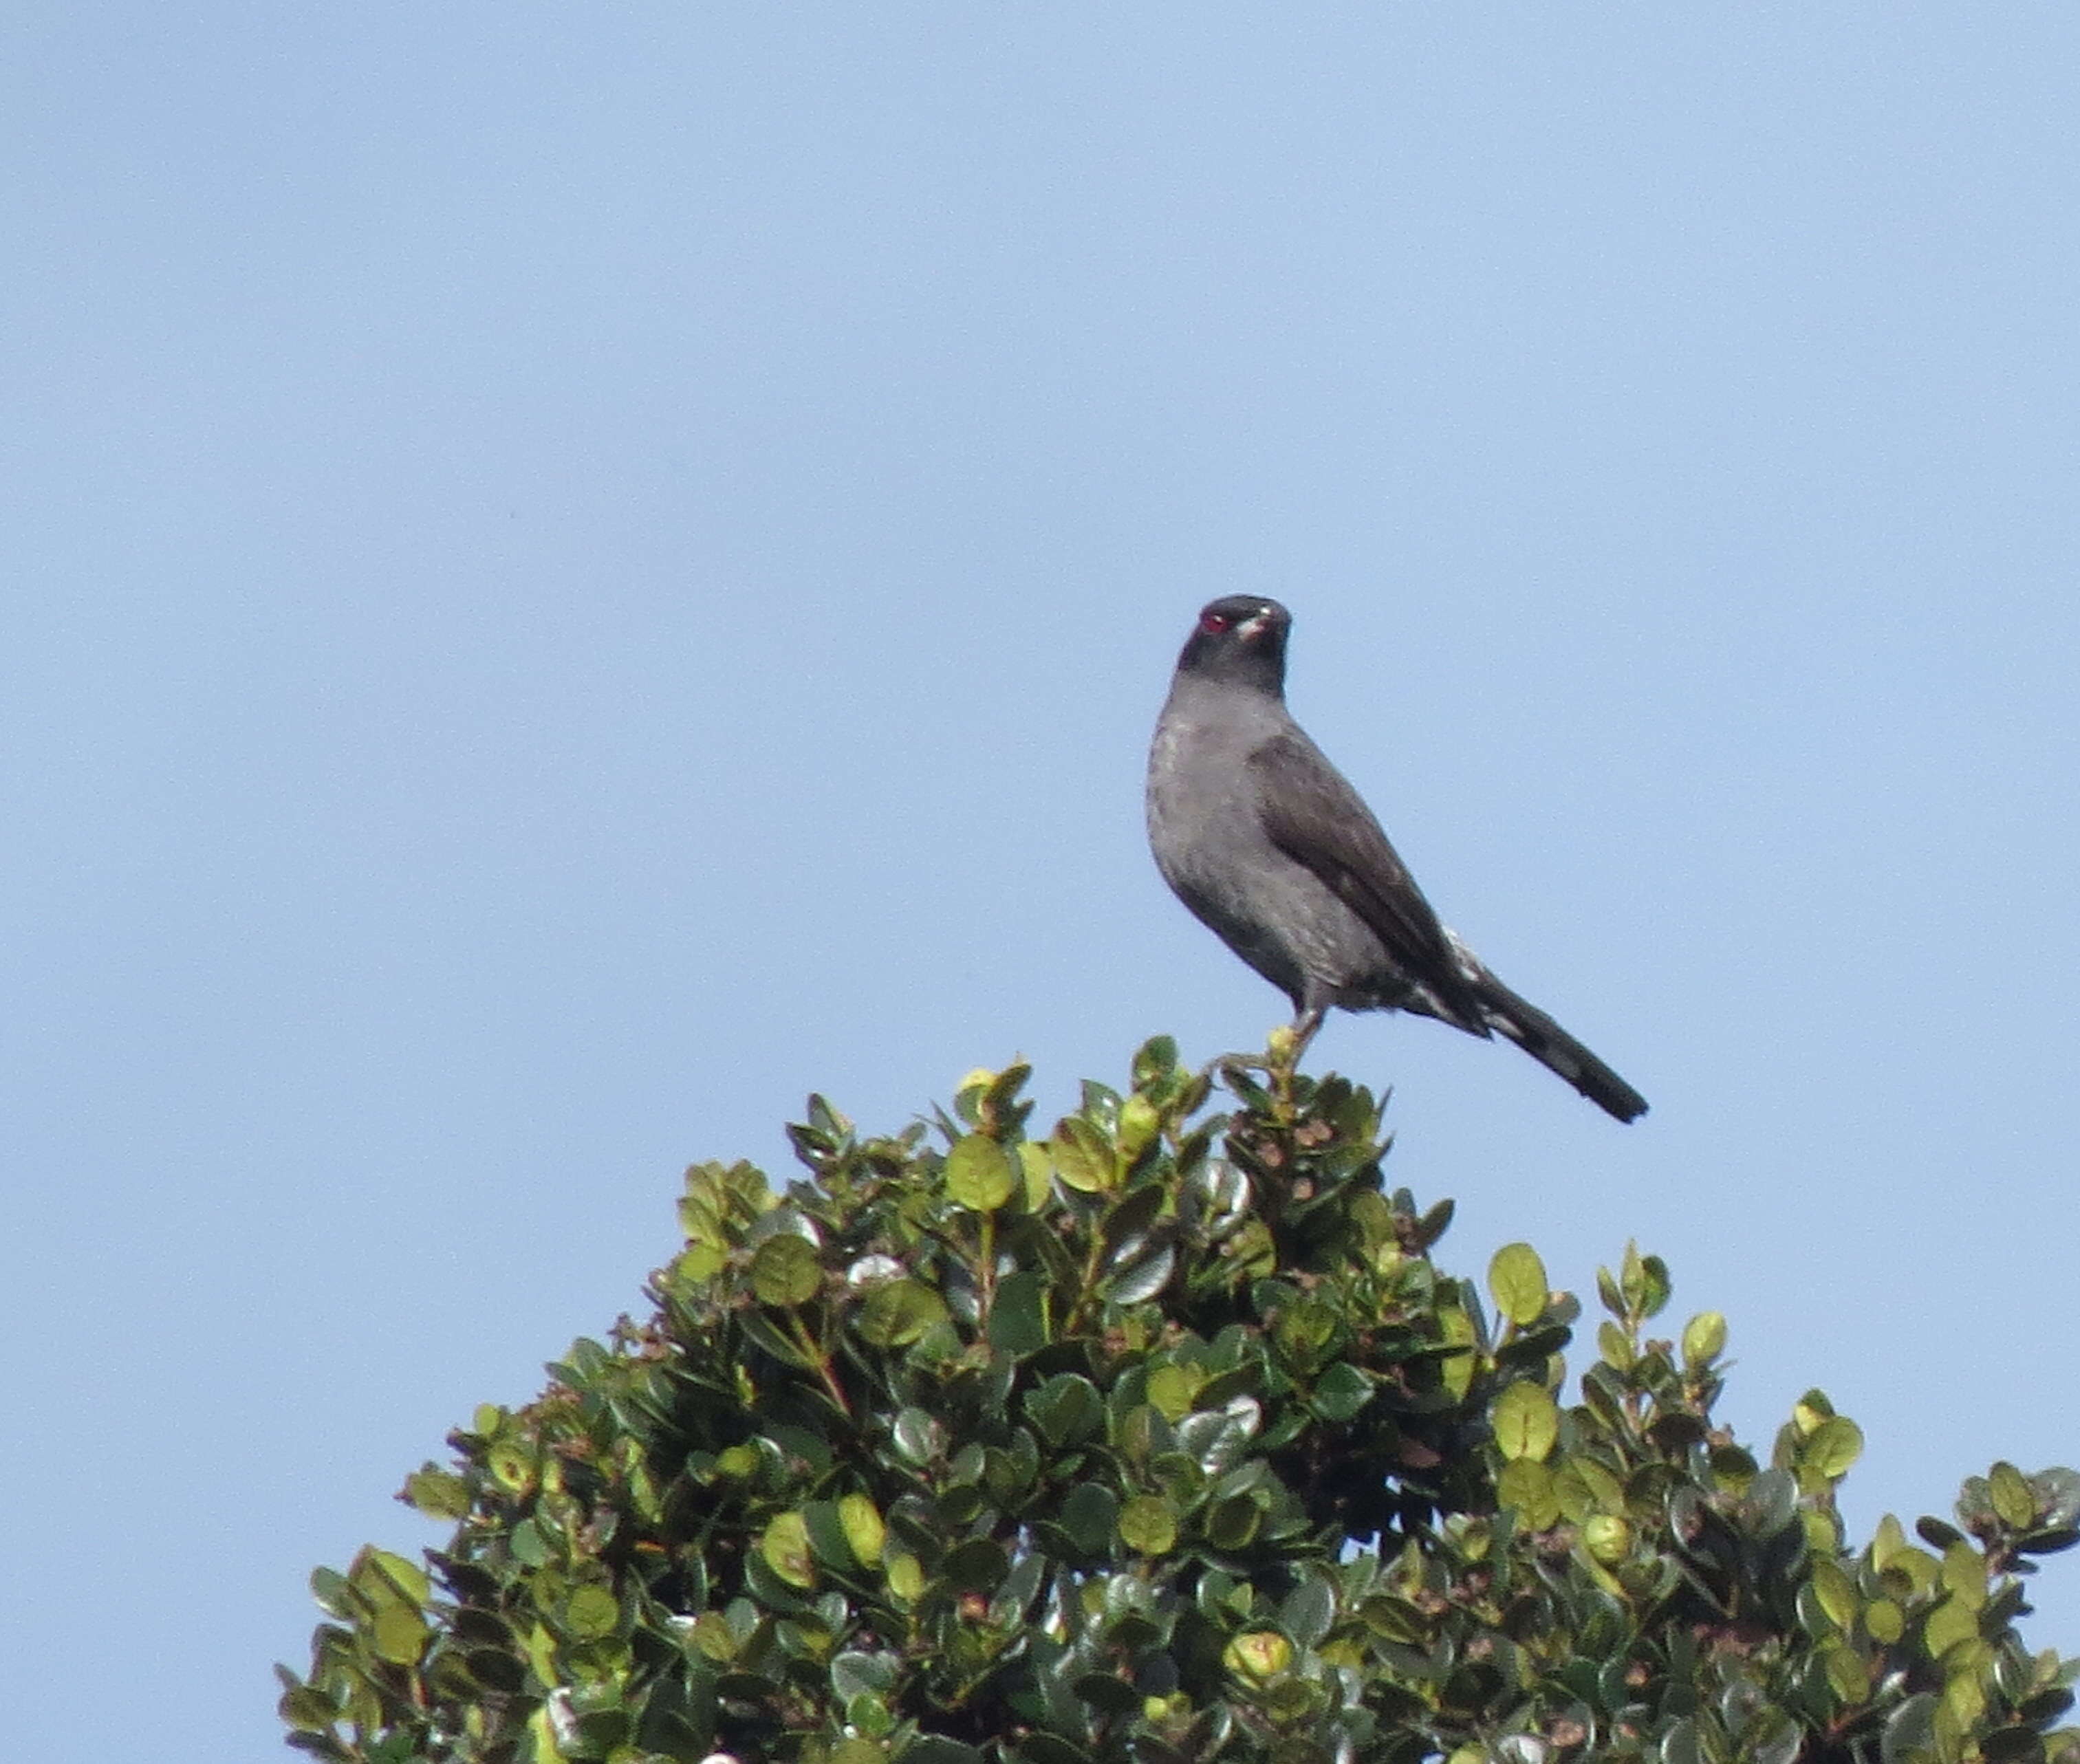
0, 0, 2080, 1760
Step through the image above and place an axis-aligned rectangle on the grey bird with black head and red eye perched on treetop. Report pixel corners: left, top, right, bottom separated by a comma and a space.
1146, 595, 1647, 1121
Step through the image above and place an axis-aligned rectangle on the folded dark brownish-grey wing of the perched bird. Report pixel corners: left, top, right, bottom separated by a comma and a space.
1248, 734, 1487, 1036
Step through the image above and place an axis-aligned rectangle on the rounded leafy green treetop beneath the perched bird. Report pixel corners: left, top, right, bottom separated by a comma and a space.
281, 1040, 2080, 1764
